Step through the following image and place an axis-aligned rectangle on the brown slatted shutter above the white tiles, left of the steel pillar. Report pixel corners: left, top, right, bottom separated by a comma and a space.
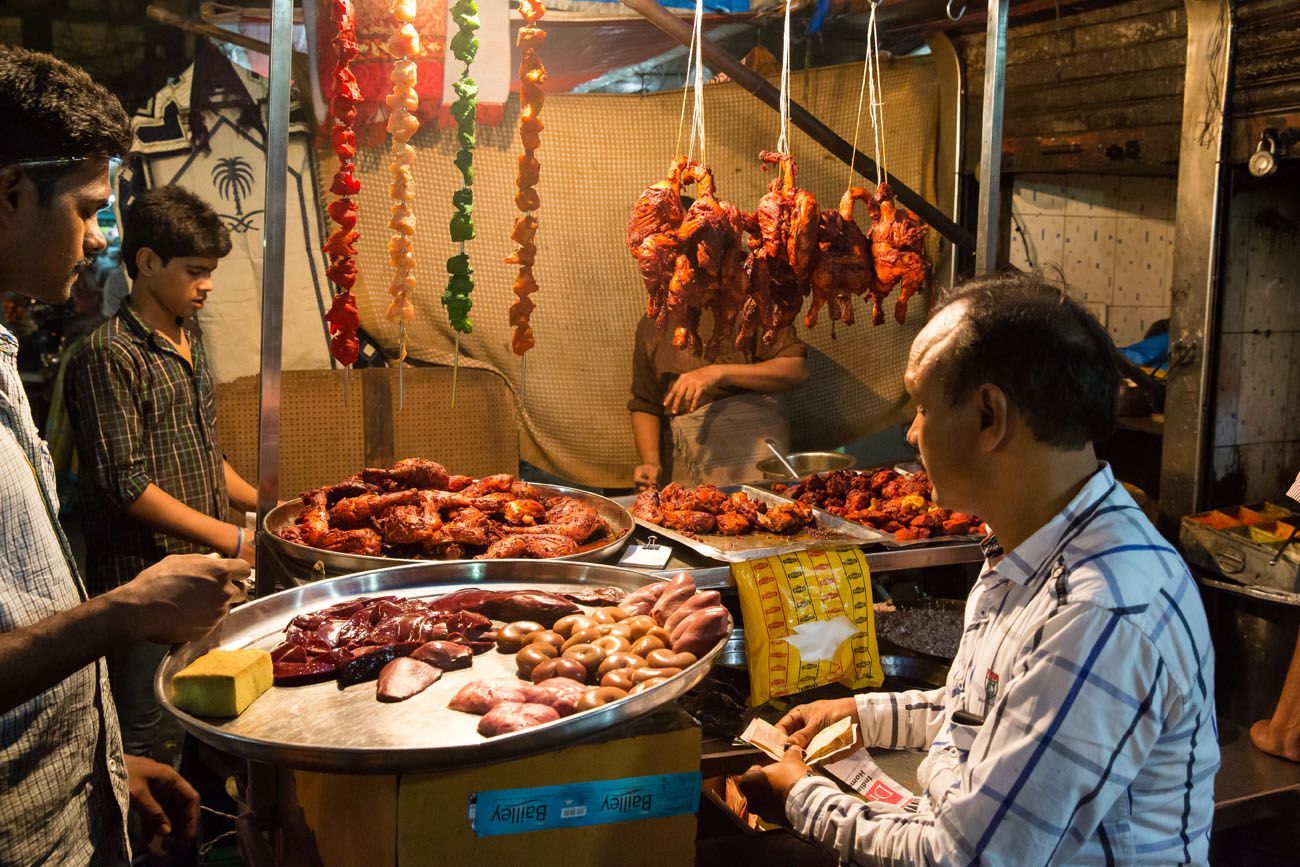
957, 0, 1187, 174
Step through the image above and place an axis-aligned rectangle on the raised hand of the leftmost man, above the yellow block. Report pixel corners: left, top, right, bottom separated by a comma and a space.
112, 554, 251, 645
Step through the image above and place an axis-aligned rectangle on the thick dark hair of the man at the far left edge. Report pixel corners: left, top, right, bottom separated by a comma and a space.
0, 45, 131, 201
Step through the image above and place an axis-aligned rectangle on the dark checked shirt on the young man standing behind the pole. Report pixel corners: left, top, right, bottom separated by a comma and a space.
65, 302, 227, 594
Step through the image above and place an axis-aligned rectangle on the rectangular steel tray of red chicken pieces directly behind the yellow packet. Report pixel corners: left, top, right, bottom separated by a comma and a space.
627, 485, 891, 563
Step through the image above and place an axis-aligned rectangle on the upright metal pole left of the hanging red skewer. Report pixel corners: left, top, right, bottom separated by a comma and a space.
257, 0, 294, 597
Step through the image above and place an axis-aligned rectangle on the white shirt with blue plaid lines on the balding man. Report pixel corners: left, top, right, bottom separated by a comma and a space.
785, 464, 1219, 864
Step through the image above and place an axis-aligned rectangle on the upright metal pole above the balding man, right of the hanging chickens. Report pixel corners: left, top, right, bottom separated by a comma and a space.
975, 0, 1011, 274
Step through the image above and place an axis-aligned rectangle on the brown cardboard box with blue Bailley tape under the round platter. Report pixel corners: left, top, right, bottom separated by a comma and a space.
294, 706, 699, 867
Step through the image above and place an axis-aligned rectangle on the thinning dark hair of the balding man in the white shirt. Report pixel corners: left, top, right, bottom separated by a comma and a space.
940, 273, 1119, 448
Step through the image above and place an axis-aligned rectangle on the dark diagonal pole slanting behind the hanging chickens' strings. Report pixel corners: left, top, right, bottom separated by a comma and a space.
623, 0, 977, 247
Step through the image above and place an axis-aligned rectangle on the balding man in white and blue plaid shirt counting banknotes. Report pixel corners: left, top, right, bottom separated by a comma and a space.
742, 276, 1219, 864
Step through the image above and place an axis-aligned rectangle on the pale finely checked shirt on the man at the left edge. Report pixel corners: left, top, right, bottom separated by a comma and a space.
0, 326, 127, 864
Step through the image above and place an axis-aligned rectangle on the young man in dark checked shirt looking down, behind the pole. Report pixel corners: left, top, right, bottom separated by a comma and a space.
65, 186, 257, 755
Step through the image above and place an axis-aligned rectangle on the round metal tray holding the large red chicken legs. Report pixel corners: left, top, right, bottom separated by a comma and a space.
263, 484, 636, 575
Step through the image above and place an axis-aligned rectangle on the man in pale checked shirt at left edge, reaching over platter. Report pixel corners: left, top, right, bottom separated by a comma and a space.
0, 47, 248, 864
